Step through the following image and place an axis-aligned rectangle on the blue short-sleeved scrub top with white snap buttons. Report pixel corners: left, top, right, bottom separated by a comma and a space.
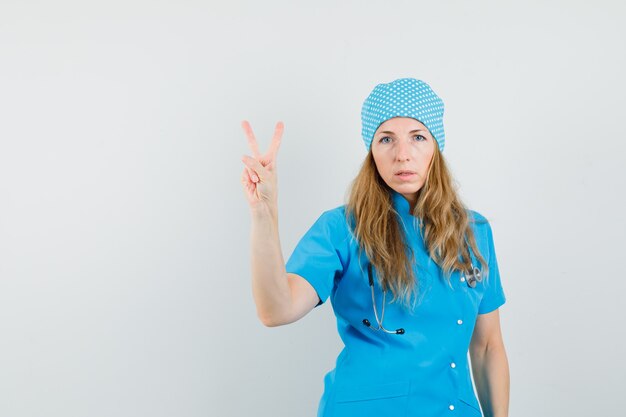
286, 191, 505, 417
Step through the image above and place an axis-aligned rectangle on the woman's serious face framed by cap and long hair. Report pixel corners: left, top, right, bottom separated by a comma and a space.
372, 117, 437, 208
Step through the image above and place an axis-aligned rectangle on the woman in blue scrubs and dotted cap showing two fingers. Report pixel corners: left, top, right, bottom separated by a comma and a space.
242, 78, 509, 417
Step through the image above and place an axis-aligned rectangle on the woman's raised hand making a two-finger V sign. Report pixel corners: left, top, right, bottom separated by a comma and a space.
241, 120, 284, 213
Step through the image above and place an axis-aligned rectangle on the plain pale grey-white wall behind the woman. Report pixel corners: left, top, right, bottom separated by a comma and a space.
0, 0, 626, 417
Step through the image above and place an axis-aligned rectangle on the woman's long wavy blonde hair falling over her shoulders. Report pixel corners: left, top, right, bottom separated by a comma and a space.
346, 146, 489, 307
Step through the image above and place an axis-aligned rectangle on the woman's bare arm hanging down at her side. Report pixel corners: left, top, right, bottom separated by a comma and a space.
469, 309, 510, 417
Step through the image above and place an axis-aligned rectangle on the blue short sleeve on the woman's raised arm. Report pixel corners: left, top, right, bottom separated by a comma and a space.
285, 209, 348, 306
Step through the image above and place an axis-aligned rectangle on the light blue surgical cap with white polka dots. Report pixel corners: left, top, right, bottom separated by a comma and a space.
361, 78, 446, 151
